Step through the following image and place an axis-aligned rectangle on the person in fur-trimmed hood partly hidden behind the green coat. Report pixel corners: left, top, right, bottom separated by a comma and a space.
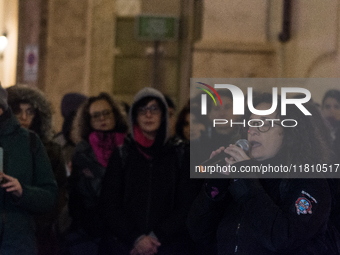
7, 85, 67, 254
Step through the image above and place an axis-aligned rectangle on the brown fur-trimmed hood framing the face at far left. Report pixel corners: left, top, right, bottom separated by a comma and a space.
7, 85, 53, 142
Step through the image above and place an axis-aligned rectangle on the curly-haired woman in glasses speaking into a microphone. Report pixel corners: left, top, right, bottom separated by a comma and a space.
187, 93, 340, 255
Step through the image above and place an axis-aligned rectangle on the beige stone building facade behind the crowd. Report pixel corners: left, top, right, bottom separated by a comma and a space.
0, 0, 340, 129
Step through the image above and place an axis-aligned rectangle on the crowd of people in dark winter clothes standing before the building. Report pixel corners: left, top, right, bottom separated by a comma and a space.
0, 82, 340, 255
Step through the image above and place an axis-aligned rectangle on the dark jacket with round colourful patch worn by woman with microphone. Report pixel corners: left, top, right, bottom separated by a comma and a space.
187, 158, 337, 255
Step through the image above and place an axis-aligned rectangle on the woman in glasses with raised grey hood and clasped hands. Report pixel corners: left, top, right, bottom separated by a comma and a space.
101, 87, 191, 255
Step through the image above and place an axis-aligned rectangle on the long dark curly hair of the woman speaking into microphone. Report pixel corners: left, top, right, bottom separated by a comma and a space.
246, 93, 332, 164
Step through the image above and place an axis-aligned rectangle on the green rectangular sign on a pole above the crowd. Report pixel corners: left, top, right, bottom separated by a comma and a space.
135, 15, 178, 41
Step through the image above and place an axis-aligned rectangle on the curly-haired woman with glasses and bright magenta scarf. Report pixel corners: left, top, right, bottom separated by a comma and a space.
65, 93, 128, 254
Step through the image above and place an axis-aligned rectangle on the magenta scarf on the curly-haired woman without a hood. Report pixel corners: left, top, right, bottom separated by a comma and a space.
89, 131, 126, 167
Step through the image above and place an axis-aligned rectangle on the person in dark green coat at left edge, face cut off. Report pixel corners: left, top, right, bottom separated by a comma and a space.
0, 82, 58, 255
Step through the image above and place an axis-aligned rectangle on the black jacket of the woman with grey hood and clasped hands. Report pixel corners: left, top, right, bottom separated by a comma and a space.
102, 138, 193, 247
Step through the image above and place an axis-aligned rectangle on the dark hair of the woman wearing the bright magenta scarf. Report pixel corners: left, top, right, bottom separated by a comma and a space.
79, 92, 128, 140
